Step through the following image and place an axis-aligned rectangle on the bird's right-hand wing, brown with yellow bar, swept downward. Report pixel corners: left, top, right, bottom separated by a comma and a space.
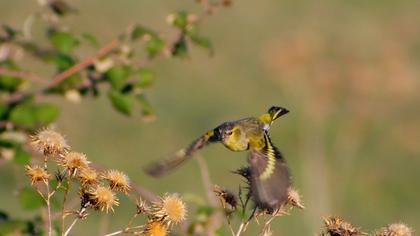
248, 134, 292, 212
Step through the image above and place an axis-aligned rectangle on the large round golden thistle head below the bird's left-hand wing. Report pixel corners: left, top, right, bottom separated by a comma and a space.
152, 194, 187, 225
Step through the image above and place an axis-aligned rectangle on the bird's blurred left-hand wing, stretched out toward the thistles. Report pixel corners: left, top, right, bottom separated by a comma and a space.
144, 131, 217, 177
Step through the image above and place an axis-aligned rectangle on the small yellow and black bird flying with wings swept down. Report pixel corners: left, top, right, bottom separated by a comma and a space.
144, 106, 291, 212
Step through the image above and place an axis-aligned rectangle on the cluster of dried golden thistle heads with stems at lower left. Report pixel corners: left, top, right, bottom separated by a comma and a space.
25, 129, 187, 236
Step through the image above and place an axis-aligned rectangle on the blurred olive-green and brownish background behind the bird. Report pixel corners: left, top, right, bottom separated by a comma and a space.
0, 0, 420, 235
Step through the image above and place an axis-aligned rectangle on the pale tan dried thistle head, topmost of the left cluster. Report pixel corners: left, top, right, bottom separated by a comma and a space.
31, 129, 70, 156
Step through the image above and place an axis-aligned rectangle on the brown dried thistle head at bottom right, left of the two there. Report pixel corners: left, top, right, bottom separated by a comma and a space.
321, 216, 363, 236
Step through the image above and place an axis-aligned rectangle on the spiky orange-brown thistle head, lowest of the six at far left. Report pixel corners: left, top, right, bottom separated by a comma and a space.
89, 186, 120, 213
